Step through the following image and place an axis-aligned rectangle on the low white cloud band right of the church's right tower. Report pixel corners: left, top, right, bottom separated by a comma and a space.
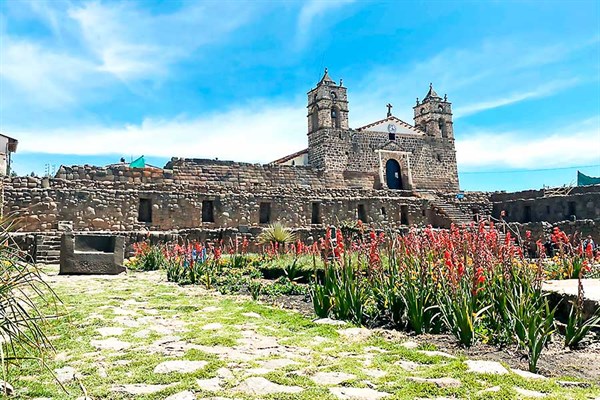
456, 117, 600, 172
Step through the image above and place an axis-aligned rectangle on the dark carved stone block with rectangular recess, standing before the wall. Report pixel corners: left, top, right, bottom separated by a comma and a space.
59, 233, 125, 275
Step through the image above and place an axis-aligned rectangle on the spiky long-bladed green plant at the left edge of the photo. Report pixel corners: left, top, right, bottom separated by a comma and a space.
0, 219, 59, 390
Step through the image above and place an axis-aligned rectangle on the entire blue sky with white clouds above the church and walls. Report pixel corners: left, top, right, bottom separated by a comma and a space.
0, 0, 600, 191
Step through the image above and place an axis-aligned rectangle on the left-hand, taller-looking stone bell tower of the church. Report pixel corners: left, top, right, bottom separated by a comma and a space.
307, 68, 348, 134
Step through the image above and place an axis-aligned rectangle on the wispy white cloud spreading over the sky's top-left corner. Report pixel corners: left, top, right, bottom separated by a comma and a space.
0, 1, 254, 108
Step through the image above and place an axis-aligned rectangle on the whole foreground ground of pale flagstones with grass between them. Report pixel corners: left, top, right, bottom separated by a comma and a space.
7, 272, 600, 400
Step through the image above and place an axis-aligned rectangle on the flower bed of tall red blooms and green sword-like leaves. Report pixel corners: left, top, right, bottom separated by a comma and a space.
127, 224, 600, 371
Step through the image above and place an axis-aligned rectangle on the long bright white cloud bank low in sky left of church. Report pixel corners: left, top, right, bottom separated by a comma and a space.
11, 105, 307, 163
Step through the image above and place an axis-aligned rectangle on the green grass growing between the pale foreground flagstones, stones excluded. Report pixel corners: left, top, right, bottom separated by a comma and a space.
7, 266, 600, 400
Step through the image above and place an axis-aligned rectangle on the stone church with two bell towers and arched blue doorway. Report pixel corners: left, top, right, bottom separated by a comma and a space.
274, 70, 459, 192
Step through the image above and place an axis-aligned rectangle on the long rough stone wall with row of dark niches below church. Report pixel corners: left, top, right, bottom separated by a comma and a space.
4, 173, 427, 231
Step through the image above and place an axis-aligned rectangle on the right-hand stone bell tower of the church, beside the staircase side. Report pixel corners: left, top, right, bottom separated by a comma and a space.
413, 83, 454, 138
